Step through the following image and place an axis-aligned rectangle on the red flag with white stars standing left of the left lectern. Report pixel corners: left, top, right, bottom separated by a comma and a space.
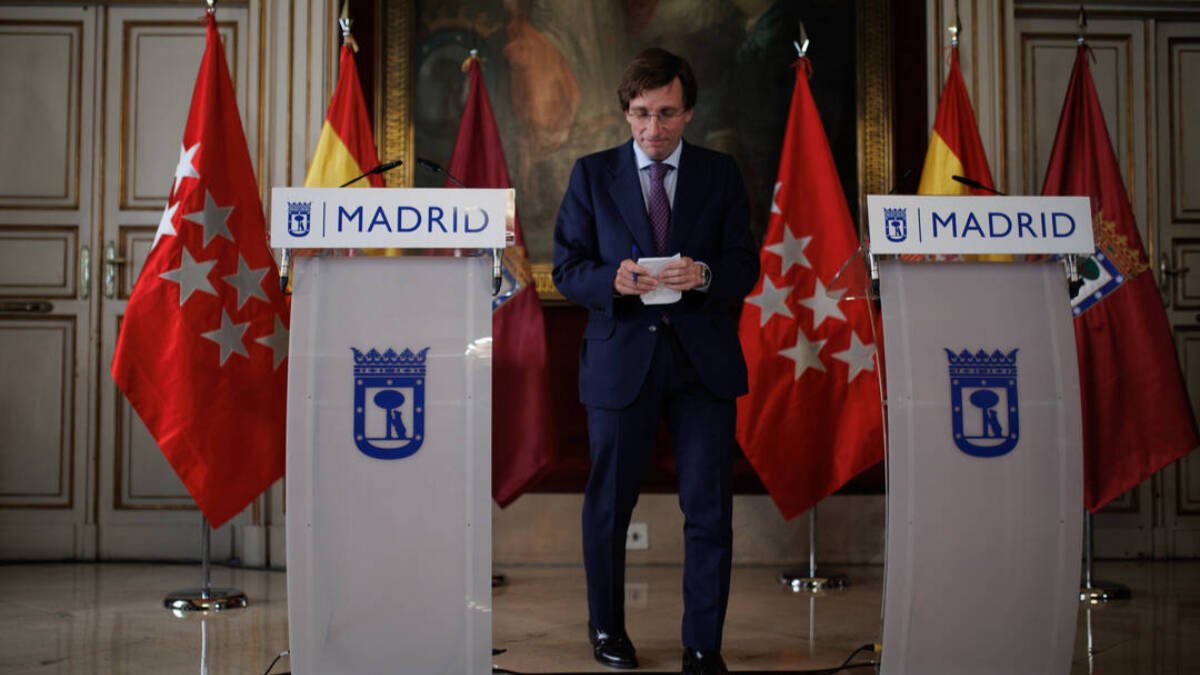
113, 13, 288, 527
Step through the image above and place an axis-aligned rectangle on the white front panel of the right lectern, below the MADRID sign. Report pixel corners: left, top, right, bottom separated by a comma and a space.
880, 261, 1084, 675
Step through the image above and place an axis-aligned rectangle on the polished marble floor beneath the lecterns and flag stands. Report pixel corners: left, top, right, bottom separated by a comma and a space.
0, 561, 1200, 675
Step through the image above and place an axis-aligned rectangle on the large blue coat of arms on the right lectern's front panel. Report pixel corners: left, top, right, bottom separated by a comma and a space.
946, 350, 1020, 458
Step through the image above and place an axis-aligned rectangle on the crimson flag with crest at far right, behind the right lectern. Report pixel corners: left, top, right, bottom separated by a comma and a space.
1042, 44, 1198, 512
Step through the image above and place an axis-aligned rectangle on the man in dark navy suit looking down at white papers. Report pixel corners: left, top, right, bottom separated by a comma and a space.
554, 49, 758, 673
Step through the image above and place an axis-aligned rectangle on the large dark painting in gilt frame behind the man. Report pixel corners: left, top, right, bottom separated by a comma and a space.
377, 0, 894, 300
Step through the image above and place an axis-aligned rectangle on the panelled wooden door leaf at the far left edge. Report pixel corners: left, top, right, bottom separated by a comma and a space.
0, 6, 100, 558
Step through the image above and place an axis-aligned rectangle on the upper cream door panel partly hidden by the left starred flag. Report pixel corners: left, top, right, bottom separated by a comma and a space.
119, 22, 241, 210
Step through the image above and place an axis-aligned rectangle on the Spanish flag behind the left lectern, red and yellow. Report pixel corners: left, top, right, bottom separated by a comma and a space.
304, 44, 383, 187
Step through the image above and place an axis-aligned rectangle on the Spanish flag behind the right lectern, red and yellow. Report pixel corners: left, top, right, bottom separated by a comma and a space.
917, 47, 995, 195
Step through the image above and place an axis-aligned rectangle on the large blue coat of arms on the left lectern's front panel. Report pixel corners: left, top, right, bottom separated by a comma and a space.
350, 347, 430, 459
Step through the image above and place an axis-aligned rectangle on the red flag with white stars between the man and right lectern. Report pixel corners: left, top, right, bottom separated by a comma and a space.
738, 59, 883, 518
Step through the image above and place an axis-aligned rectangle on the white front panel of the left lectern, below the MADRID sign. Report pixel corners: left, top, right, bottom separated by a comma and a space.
287, 256, 492, 675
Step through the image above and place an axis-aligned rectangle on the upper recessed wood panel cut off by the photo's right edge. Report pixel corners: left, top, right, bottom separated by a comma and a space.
1164, 37, 1200, 223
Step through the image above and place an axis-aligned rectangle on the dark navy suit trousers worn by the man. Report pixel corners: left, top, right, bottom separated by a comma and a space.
583, 323, 737, 651
